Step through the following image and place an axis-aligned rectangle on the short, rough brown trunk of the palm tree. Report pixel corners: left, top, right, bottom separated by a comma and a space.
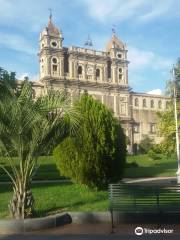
9, 185, 34, 219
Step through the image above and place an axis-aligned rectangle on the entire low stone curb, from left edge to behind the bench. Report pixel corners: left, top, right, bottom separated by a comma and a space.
0, 211, 180, 234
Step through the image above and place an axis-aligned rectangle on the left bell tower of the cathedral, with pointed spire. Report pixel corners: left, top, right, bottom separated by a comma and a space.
39, 11, 64, 80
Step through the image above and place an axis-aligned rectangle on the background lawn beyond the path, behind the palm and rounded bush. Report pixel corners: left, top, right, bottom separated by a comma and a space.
0, 155, 177, 181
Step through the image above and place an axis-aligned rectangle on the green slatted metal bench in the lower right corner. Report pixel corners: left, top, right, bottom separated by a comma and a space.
108, 183, 180, 231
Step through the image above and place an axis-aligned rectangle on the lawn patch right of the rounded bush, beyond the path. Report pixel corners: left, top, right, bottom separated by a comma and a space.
124, 155, 177, 178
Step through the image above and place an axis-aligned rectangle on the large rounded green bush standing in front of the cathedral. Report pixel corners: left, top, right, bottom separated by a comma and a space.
54, 94, 126, 188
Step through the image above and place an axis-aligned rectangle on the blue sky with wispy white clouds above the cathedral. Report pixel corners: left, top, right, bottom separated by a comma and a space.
0, 0, 180, 94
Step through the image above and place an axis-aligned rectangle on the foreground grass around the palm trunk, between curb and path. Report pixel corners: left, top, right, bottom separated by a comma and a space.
0, 183, 108, 218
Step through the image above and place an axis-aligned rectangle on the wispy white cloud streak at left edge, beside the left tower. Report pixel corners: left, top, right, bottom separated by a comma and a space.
0, 32, 37, 55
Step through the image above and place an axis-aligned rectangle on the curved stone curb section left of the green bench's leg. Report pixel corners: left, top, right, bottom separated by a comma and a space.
0, 212, 111, 234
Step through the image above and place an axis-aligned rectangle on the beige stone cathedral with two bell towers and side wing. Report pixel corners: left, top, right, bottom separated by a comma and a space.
33, 15, 169, 153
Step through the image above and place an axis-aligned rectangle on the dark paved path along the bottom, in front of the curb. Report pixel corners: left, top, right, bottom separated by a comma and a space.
0, 224, 180, 240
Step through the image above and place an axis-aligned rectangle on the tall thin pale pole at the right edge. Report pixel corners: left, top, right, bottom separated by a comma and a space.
172, 67, 180, 184
